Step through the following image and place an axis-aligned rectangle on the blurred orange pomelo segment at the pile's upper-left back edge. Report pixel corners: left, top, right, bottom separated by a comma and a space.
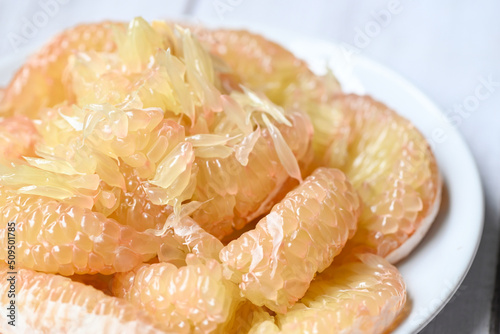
0, 22, 123, 118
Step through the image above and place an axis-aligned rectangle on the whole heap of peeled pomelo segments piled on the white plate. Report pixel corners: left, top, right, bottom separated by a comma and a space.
0, 18, 441, 333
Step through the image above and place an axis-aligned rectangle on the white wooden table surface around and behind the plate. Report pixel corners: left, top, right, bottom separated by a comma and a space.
0, 0, 500, 334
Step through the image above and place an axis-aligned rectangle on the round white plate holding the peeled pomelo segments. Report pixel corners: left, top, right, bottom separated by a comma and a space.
0, 22, 484, 334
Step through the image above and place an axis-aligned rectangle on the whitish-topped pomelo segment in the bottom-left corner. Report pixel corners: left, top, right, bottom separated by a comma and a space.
0, 266, 164, 334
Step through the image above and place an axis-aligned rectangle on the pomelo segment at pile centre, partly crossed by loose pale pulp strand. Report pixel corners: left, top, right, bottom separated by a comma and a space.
192, 112, 312, 238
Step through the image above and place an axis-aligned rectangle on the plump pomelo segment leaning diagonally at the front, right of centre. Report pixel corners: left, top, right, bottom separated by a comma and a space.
220, 168, 360, 313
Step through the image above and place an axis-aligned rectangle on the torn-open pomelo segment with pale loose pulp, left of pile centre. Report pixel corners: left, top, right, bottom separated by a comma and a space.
29, 105, 194, 219
